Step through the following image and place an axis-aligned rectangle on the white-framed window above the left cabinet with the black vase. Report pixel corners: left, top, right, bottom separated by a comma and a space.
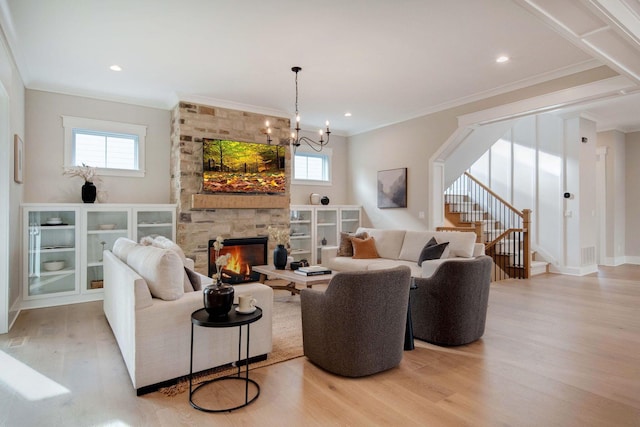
62, 116, 147, 177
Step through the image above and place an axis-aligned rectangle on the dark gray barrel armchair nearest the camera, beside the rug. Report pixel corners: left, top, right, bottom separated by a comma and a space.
300, 266, 411, 377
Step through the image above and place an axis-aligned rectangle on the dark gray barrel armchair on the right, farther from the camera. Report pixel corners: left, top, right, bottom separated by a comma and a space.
411, 255, 493, 345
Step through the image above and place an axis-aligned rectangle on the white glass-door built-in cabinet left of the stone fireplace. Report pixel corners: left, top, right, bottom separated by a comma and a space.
22, 204, 176, 308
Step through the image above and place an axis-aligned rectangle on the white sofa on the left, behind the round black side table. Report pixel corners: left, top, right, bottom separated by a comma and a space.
103, 239, 273, 395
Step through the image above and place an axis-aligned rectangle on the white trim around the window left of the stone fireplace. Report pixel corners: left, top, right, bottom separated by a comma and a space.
62, 116, 147, 178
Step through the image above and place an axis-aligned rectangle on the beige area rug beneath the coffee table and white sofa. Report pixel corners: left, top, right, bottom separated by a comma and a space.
158, 291, 303, 396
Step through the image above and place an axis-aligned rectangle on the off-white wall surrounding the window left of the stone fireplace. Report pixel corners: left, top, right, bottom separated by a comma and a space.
24, 90, 171, 203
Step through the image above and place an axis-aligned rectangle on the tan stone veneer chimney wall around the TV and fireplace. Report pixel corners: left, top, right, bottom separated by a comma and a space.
170, 102, 291, 274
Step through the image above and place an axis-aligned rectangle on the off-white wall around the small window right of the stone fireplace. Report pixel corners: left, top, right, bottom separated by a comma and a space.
290, 132, 349, 205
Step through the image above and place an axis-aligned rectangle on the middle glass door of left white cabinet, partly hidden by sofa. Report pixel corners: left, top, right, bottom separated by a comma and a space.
81, 209, 130, 292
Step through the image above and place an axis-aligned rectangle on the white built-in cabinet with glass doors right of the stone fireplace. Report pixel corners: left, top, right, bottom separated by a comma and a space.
289, 205, 361, 265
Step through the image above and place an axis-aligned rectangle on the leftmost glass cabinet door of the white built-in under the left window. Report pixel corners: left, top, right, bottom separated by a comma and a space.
25, 210, 78, 298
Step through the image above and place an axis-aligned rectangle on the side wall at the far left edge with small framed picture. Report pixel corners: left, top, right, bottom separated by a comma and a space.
0, 31, 25, 333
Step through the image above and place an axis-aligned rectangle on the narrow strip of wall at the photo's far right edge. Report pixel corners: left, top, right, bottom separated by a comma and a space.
625, 132, 640, 264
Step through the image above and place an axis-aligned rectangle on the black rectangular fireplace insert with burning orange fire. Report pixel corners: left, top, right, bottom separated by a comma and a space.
209, 237, 268, 285
